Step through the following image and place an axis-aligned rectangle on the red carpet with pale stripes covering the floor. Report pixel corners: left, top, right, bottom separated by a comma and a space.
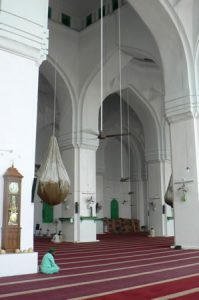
0, 234, 199, 300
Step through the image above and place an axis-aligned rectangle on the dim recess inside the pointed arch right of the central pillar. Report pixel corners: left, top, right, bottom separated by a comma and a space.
96, 93, 147, 218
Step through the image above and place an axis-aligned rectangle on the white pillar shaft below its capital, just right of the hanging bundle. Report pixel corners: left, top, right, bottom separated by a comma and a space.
62, 146, 96, 242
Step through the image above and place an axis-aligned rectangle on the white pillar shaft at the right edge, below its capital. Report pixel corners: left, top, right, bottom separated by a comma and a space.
170, 115, 199, 248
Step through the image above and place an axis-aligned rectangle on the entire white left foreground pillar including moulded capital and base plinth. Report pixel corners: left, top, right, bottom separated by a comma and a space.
0, 0, 48, 275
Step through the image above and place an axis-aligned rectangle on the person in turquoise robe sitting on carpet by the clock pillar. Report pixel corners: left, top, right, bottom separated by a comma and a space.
40, 248, 60, 274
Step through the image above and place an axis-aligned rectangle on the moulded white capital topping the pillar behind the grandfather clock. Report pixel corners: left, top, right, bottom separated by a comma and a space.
0, 0, 49, 65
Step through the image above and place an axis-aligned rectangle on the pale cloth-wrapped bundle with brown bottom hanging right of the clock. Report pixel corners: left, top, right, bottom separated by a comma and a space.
37, 136, 70, 205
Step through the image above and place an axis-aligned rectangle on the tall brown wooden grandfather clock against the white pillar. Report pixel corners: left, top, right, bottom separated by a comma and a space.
2, 166, 23, 252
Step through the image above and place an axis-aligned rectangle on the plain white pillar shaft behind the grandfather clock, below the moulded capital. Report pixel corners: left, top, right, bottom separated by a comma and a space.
0, 51, 38, 249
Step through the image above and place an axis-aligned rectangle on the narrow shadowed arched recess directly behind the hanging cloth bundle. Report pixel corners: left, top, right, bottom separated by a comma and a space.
34, 61, 74, 234
